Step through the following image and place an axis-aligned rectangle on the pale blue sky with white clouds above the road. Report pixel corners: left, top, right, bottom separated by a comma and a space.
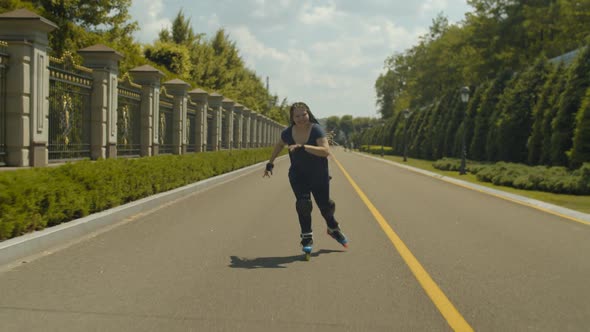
130, 0, 472, 118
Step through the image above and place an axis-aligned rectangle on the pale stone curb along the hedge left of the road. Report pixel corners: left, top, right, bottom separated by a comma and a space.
0, 157, 284, 266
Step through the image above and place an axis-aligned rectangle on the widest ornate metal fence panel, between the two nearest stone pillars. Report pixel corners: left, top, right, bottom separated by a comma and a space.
47, 53, 92, 161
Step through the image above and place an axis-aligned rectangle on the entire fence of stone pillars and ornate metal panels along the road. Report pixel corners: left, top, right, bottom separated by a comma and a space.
0, 9, 284, 167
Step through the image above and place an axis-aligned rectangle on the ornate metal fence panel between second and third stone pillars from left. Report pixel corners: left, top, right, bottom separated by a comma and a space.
117, 74, 141, 156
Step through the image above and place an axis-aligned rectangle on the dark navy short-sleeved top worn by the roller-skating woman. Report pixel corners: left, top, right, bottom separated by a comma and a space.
281, 123, 328, 174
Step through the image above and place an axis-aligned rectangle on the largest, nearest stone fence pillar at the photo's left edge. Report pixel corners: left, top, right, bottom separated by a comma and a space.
0, 9, 57, 167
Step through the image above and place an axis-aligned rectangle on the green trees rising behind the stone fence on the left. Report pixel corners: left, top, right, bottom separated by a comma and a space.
0, 0, 289, 124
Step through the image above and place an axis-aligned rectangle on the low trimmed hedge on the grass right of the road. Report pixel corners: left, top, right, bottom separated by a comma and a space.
433, 158, 590, 195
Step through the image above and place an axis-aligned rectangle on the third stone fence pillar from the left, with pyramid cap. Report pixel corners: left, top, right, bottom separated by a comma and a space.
129, 65, 164, 156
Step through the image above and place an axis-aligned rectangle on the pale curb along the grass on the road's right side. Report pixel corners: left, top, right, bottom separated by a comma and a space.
354, 152, 590, 226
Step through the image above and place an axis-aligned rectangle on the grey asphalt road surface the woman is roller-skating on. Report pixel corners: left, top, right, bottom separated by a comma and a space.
0, 149, 590, 332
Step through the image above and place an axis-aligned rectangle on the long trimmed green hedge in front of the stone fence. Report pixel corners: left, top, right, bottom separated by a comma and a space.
0, 148, 272, 241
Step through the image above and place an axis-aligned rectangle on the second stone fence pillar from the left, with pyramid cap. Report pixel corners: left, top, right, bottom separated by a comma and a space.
78, 44, 123, 160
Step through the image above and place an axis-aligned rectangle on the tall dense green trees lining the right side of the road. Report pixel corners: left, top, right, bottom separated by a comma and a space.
366, 0, 590, 168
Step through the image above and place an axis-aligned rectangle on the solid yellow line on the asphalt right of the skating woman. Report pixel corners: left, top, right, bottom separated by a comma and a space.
332, 155, 473, 331
